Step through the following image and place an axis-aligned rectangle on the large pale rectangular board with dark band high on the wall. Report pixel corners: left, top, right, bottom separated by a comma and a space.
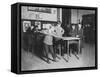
21, 6, 57, 21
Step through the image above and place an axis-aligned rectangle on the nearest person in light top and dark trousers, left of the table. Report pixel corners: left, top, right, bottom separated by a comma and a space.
43, 24, 56, 63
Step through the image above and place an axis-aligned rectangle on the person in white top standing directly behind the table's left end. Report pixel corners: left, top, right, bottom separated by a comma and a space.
55, 21, 68, 62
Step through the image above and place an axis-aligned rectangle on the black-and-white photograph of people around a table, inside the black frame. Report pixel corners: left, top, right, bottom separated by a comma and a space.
21, 5, 96, 71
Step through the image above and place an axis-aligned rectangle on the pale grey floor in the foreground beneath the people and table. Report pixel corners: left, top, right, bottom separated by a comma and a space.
21, 44, 95, 71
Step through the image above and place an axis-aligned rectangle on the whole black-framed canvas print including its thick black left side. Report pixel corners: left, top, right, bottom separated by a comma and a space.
11, 3, 98, 74
